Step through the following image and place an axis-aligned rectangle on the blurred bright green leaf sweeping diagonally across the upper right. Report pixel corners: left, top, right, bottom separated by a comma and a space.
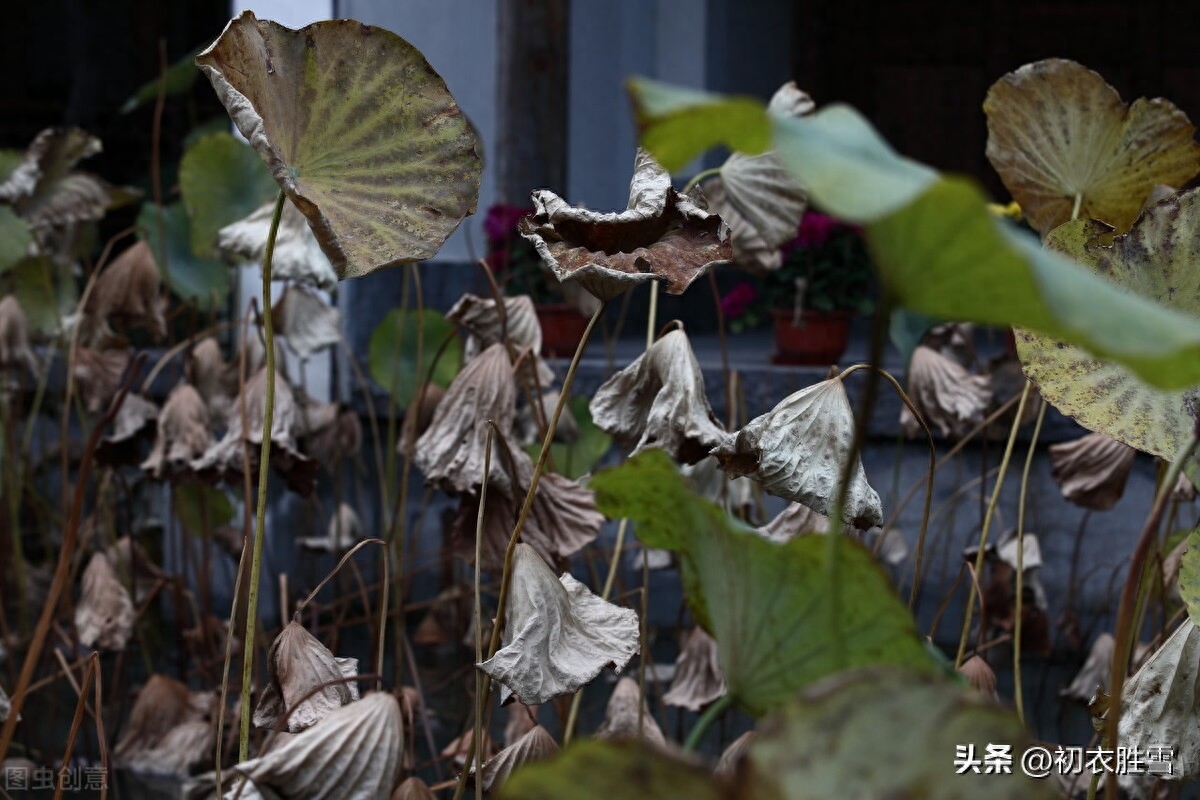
631, 83, 1200, 387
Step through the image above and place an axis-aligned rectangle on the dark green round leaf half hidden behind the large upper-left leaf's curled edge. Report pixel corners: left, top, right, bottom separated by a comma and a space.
179, 131, 278, 258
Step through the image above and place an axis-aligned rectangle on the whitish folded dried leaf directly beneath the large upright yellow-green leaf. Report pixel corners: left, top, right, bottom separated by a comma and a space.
217, 200, 337, 289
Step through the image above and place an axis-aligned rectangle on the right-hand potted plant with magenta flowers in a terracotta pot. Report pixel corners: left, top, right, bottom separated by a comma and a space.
763, 211, 875, 365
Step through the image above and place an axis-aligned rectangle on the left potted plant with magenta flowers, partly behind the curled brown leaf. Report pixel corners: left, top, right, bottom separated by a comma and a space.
484, 203, 588, 356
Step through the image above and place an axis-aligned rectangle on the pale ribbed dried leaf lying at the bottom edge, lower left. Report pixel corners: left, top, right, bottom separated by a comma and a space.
236, 692, 403, 800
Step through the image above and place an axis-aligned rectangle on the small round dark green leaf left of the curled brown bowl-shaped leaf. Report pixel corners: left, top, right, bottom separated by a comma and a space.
367, 308, 462, 408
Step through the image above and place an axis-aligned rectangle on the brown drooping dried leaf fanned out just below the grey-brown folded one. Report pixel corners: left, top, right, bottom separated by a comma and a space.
454, 446, 604, 570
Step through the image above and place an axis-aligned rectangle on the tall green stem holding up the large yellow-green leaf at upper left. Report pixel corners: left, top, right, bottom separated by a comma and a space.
238, 192, 287, 762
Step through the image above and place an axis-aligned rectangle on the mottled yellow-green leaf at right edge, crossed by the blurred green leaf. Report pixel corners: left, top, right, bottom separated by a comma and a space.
1016, 191, 1200, 471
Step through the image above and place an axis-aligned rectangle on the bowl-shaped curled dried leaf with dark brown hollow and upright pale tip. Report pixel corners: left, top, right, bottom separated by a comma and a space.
518, 148, 733, 300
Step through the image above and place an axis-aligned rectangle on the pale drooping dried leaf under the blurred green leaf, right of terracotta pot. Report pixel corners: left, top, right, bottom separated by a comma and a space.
900, 344, 991, 438
